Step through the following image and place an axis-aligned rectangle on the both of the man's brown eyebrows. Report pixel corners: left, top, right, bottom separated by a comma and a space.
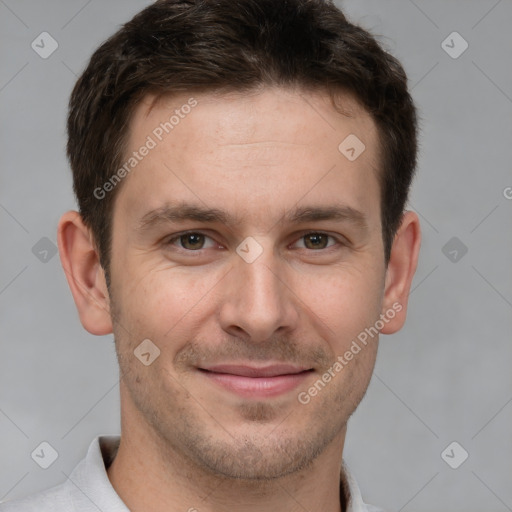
136, 202, 368, 232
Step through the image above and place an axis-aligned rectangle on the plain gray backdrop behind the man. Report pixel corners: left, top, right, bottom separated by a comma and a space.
0, 0, 512, 512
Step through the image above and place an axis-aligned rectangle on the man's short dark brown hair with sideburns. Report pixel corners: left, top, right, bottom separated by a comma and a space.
67, 0, 417, 283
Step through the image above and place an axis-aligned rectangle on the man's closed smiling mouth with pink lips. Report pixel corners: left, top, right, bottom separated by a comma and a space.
198, 364, 314, 398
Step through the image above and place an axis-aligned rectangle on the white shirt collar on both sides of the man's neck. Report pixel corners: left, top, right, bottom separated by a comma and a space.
69, 436, 374, 512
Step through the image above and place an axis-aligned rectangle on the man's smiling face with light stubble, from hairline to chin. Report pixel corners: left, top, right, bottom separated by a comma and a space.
111, 88, 386, 478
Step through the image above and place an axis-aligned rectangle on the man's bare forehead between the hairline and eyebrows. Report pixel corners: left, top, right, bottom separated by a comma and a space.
118, 88, 379, 230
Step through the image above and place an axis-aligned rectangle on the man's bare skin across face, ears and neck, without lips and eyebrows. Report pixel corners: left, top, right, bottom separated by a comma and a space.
58, 88, 420, 512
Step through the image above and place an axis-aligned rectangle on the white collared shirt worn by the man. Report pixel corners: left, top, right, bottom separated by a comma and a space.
0, 436, 384, 512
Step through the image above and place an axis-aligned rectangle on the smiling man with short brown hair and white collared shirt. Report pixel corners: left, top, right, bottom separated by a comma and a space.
0, 0, 420, 512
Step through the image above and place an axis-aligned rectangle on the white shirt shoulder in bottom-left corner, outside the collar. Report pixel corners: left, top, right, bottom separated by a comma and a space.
0, 483, 74, 512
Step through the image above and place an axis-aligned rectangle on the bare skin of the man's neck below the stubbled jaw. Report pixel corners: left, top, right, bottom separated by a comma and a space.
107, 381, 346, 512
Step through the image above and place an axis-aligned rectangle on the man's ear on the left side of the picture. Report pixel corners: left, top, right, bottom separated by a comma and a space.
57, 211, 112, 336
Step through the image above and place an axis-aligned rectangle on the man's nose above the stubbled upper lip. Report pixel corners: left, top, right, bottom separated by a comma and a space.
220, 241, 300, 343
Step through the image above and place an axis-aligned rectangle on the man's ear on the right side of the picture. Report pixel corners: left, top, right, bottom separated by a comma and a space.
380, 211, 421, 334
